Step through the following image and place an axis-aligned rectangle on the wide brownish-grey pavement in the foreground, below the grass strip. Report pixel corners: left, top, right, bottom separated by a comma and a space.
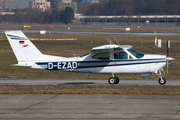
0, 95, 180, 120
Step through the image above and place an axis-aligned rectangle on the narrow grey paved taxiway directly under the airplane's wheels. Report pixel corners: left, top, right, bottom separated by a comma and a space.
0, 78, 180, 85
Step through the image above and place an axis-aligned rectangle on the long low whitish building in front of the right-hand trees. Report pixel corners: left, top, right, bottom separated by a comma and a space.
75, 14, 180, 26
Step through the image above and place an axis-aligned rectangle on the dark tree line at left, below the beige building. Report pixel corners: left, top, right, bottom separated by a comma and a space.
0, 7, 74, 24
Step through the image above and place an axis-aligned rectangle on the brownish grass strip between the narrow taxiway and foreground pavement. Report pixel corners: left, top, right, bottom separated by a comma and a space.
0, 85, 180, 95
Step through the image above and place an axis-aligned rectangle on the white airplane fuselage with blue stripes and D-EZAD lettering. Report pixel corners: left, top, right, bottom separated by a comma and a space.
34, 54, 166, 74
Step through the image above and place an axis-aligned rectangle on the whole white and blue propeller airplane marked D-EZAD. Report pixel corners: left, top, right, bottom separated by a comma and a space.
5, 30, 175, 85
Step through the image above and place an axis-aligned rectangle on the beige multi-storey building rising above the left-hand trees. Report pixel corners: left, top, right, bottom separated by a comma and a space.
29, 0, 51, 11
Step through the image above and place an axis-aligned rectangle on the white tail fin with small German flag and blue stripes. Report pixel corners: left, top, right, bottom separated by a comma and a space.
5, 31, 43, 62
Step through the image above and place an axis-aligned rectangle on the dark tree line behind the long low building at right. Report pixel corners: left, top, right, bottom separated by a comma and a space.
83, 0, 180, 16
